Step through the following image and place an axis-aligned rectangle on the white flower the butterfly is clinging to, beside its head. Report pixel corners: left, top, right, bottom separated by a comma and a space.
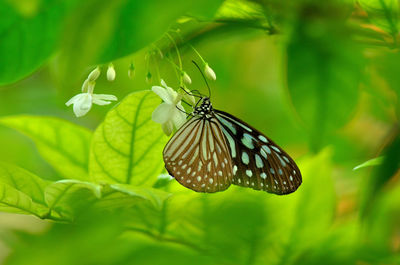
151, 80, 186, 135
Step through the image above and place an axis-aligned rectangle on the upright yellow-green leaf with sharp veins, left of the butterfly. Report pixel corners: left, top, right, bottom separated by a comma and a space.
89, 91, 167, 185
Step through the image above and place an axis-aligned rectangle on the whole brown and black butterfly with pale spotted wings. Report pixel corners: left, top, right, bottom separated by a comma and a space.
163, 97, 302, 195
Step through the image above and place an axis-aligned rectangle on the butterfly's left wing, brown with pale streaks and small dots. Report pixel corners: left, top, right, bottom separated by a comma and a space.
163, 117, 233, 192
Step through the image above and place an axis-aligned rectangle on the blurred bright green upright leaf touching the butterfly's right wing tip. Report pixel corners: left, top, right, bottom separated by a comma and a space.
280, 148, 336, 264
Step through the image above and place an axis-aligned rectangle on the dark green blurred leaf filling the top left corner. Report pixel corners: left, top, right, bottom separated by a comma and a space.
0, 0, 76, 85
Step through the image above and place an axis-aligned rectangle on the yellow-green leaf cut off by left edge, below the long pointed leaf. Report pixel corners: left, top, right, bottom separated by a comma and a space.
0, 163, 48, 217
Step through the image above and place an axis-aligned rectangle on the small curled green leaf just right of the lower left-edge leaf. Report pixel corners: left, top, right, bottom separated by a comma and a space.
45, 179, 101, 221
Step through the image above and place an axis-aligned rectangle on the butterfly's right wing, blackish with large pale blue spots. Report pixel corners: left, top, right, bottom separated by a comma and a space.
214, 110, 302, 194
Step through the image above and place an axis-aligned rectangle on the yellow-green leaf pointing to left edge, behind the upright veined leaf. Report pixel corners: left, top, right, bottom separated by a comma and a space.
0, 115, 92, 180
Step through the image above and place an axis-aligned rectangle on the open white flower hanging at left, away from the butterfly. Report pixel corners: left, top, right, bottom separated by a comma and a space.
65, 88, 118, 117
